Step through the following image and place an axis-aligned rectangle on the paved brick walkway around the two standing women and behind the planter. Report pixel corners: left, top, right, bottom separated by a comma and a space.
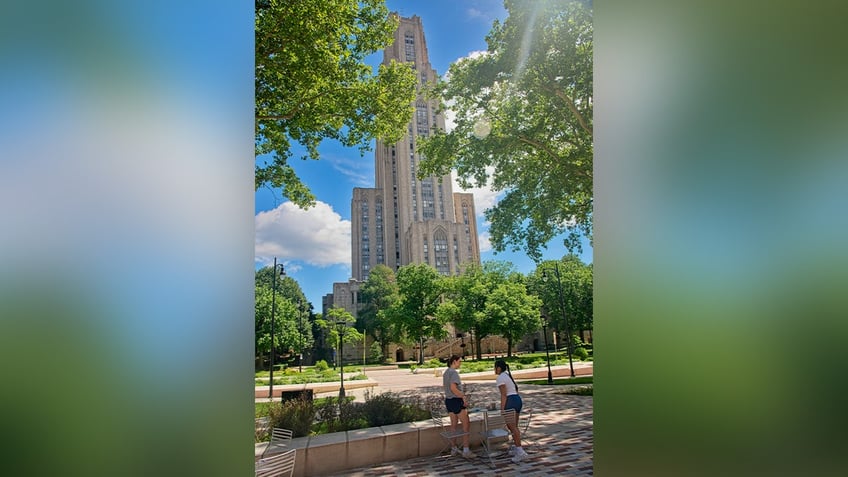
314, 369, 593, 477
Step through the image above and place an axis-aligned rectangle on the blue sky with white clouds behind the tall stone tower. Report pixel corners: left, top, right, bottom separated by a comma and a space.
255, 0, 592, 311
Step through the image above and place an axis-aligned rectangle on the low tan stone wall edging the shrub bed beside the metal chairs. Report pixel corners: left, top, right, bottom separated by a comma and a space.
255, 412, 483, 477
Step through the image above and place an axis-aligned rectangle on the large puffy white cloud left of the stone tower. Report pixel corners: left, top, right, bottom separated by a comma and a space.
254, 201, 350, 272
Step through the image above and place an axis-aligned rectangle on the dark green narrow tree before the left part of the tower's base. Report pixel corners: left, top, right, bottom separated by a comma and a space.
357, 265, 400, 356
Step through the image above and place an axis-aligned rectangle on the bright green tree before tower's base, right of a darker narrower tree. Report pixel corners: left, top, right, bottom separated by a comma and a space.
384, 264, 446, 364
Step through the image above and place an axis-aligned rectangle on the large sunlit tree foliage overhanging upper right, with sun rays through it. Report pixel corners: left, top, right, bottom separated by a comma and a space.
419, 0, 593, 261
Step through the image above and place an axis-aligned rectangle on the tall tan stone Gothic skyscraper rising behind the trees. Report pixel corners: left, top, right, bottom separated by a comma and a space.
332, 15, 480, 314
